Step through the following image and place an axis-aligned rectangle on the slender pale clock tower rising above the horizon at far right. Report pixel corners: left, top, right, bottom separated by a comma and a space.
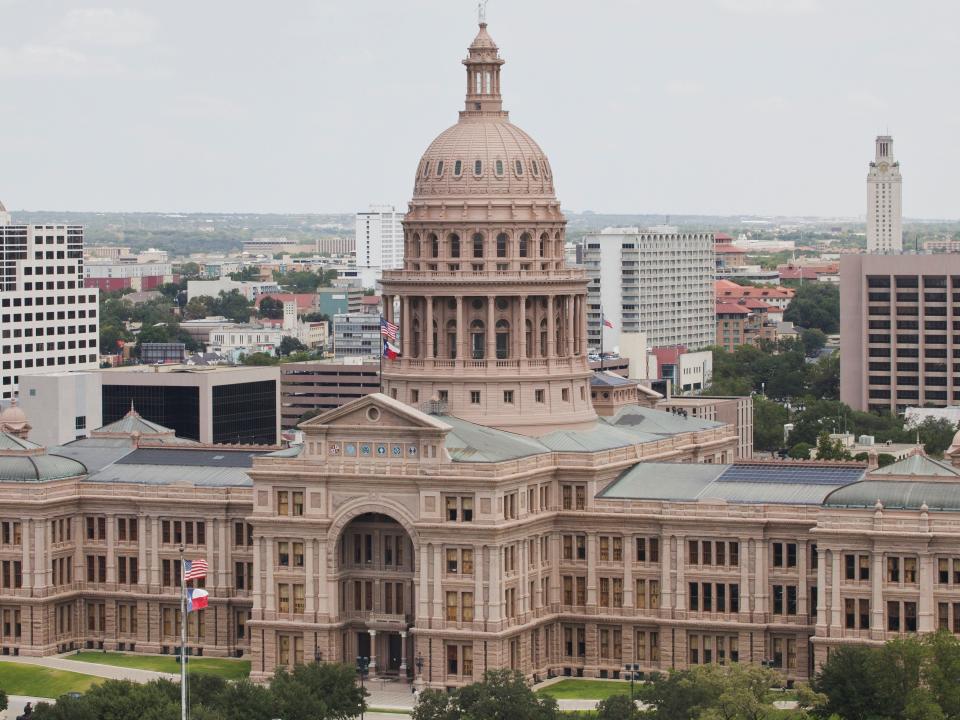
867, 135, 903, 253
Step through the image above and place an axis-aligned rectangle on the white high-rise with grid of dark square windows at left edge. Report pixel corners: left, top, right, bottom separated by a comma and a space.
0, 217, 100, 399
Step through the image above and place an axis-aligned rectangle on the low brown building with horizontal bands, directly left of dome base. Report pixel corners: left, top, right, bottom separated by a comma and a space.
280, 356, 386, 430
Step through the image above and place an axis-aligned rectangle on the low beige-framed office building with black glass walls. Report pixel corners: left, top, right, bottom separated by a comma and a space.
100, 365, 280, 445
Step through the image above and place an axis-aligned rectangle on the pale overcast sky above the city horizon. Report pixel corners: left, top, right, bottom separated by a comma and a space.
0, 0, 960, 218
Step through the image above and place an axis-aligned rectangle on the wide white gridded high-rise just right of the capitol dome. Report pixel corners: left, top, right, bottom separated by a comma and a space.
583, 227, 717, 352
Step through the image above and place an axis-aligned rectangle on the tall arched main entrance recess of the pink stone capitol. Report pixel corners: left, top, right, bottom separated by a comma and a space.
336, 512, 416, 677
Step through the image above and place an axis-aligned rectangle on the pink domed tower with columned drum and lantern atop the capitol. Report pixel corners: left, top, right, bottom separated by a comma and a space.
383, 22, 596, 434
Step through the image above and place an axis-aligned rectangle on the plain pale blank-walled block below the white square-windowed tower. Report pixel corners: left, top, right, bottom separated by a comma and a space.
18, 371, 103, 447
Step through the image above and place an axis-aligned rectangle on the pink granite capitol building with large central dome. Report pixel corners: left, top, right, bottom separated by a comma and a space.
0, 18, 960, 688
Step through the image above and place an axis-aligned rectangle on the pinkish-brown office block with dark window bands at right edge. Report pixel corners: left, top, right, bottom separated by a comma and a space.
840, 255, 960, 414
